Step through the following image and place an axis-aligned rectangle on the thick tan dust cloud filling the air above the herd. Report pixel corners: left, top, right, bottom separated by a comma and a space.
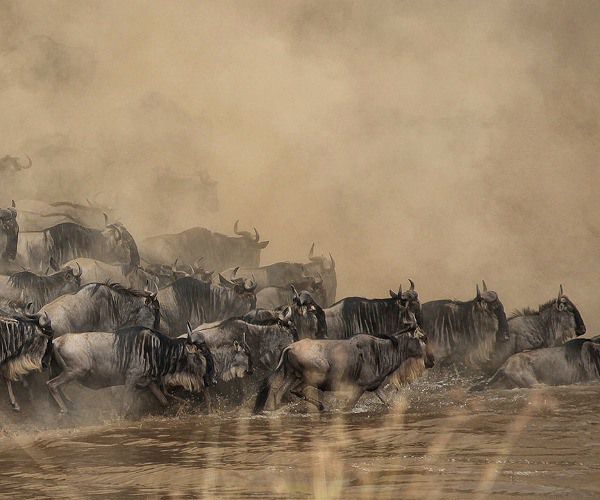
0, 1, 600, 333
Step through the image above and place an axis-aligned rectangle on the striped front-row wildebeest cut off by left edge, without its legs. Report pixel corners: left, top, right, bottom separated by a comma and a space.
0, 317, 52, 381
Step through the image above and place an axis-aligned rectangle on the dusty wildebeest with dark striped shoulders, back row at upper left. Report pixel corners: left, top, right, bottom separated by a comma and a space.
18, 219, 140, 272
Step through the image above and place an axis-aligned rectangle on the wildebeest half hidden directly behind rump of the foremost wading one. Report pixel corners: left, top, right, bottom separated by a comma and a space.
192, 315, 294, 372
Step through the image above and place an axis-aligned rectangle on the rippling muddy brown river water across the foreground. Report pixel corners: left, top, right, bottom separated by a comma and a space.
0, 386, 600, 499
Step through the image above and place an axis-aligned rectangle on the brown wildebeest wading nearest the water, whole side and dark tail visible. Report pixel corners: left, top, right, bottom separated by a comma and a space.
254, 325, 431, 413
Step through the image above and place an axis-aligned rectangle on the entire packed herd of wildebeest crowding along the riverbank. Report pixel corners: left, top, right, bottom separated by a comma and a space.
0, 200, 600, 414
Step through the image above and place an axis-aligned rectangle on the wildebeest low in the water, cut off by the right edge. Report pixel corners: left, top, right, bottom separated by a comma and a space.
473, 337, 600, 390
